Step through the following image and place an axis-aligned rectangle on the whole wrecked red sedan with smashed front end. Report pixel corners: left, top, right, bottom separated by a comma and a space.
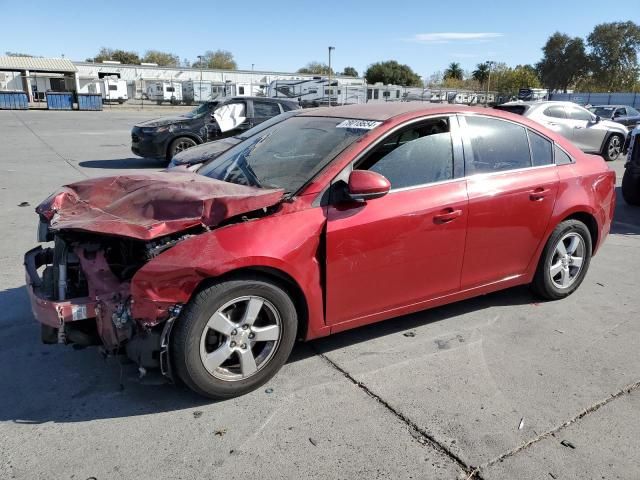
25, 102, 615, 398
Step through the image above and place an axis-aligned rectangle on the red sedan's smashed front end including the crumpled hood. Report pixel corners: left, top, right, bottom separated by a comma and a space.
24, 174, 282, 377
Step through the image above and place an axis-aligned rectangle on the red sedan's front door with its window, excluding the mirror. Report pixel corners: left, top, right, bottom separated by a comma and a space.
326, 117, 467, 324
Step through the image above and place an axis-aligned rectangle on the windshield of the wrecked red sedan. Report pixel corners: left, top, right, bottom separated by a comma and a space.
198, 116, 372, 193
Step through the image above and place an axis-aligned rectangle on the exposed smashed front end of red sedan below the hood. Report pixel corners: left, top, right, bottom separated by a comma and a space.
24, 232, 181, 374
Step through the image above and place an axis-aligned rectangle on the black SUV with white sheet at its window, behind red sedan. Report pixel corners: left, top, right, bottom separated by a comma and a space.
131, 97, 300, 161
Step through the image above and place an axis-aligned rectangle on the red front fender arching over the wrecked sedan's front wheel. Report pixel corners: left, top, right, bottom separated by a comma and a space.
131, 195, 329, 339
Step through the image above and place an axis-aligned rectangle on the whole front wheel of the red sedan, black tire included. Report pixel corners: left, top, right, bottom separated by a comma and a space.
170, 276, 298, 399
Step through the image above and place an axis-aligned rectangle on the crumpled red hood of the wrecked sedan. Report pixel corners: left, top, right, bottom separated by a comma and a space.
36, 172, 284, 240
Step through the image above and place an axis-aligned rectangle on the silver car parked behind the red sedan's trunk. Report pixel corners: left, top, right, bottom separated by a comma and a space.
495, 102, 628, 162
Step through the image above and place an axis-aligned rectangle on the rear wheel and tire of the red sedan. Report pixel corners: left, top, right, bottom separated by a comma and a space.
531, 220, 592, 300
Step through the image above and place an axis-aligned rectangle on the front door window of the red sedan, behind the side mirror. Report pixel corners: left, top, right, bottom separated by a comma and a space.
357, 118, 453, 190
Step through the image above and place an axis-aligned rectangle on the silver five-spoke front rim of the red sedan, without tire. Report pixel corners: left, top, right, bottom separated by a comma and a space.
200, 295, 282, 381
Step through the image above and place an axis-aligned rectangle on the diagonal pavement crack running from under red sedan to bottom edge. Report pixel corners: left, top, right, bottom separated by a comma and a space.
311, 345, 483, 480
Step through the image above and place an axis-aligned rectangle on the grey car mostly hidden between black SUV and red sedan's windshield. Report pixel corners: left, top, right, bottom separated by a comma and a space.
168, 110, 301, 169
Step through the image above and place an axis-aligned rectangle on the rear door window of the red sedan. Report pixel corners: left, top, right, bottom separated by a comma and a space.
465, 116, 531, 176
